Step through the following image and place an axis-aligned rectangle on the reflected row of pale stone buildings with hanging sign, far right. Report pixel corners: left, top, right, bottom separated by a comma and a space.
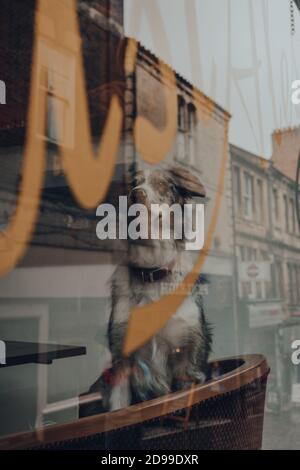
231, 130, 300, 410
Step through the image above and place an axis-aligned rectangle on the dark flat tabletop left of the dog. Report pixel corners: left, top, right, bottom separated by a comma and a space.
0, 341, 86, 368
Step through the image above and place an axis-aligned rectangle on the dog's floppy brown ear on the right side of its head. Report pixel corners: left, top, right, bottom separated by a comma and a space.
169, 165, 206, 197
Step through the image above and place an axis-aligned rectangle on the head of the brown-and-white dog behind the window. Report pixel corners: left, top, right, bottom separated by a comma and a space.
129, 165, 205, 267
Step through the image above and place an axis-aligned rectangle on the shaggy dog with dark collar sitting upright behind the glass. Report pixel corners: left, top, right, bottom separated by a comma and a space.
84, 166, 212, 411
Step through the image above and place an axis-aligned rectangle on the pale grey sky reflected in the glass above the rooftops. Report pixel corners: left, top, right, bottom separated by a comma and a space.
125, 0, 300, 158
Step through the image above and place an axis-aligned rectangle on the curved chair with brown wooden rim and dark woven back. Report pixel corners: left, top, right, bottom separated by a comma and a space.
0, 355, 269, 450
